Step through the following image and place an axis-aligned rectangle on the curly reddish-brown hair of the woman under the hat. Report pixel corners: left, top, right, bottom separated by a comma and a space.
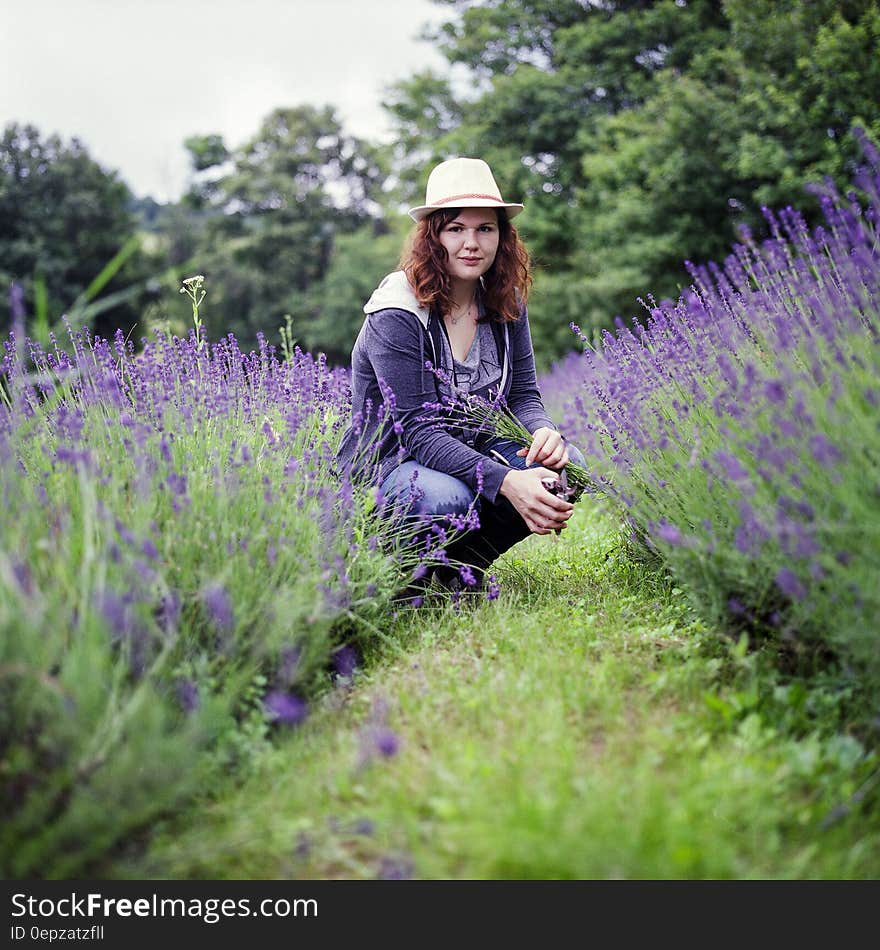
400, 208, 532, 323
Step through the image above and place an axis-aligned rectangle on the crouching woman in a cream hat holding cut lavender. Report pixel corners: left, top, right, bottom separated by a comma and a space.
338, 158, 583, 600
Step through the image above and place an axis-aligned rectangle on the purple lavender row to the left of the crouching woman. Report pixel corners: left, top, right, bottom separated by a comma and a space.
0, 325, 426, 877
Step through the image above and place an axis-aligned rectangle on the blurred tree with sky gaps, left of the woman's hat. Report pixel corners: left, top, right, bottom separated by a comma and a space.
174, 106, 387, 343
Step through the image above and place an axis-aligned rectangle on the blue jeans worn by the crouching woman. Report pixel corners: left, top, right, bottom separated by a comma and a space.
381, 439, 586, 580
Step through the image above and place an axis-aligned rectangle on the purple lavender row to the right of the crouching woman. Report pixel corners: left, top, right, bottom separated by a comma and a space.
544, 130, 880, 703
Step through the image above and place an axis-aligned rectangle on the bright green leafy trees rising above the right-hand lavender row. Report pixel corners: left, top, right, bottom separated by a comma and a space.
575, 0, 880, 321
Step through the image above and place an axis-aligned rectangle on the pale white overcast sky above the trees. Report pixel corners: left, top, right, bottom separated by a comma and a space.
0, 0, 445, 201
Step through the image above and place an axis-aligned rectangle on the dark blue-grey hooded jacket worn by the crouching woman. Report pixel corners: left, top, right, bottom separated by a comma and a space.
337, 271, 556, 502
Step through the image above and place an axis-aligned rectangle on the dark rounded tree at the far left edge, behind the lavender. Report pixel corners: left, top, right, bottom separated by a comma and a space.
0, 123, 149, 336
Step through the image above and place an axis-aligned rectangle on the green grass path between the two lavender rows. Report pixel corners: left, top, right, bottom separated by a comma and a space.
108, 501, 880, 880
